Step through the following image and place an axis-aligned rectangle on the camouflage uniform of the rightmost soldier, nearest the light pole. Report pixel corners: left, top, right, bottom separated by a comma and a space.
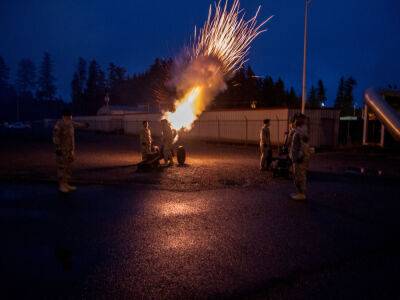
289, 126, 310, 194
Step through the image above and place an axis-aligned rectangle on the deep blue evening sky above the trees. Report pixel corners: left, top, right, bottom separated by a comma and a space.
0, 0, 400, 103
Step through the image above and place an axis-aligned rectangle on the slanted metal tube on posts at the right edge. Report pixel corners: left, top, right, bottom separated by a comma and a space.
363, 88, 400, 147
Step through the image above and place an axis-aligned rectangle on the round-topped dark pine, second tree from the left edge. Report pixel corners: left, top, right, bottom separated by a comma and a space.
16, 58, 36, 96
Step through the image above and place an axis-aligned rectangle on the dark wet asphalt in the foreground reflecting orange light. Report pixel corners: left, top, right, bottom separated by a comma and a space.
0, 176, 400, 299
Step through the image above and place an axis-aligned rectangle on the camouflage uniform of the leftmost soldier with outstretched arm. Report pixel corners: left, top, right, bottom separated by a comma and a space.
53, 119, 85, 182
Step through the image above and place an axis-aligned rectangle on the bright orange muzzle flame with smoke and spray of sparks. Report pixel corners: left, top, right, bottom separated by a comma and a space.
164, 0, 271, 130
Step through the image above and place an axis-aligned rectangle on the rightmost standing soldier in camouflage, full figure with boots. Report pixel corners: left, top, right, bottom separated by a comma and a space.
289, 115, 310, 201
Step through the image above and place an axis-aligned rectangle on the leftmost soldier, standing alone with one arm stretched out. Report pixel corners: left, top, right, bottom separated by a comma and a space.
53, 109, 89, 193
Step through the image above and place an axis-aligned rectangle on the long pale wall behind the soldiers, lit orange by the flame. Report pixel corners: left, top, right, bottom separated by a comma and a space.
76, 109, 339, 147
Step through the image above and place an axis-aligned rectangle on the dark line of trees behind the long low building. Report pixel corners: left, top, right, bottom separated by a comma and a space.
0, 52, 356, 120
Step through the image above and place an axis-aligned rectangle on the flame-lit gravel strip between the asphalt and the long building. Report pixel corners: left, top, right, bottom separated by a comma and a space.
0, 132, 400, 191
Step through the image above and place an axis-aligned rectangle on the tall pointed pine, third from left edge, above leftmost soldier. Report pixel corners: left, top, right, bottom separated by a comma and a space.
37, 52, 57, 101
